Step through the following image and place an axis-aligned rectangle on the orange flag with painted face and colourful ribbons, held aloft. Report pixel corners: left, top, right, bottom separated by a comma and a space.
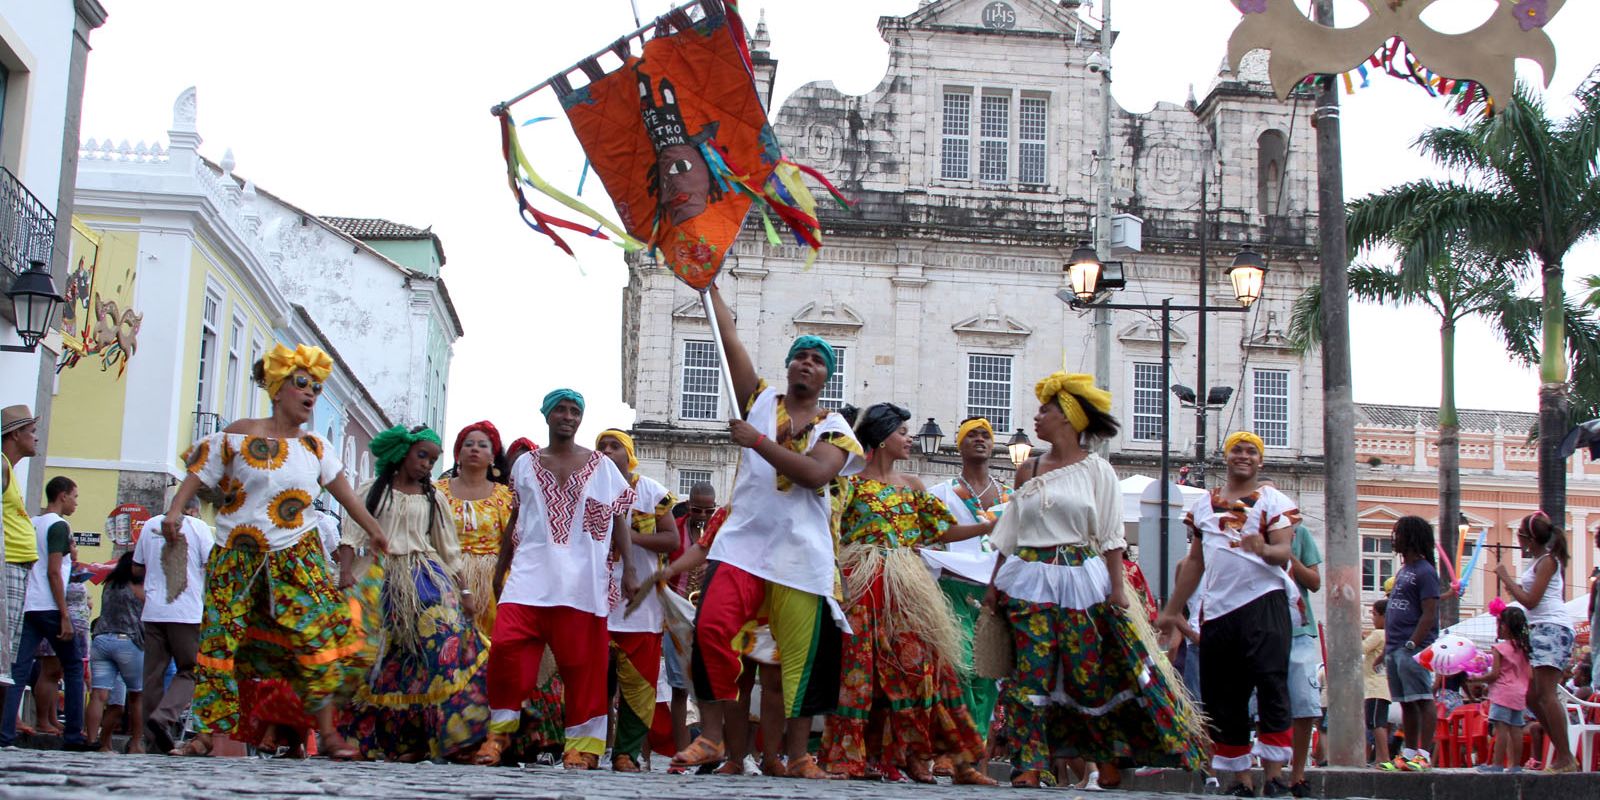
502, 0, 848, 290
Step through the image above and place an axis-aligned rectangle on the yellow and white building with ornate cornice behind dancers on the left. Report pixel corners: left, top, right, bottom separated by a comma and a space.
46, 88, 461, 560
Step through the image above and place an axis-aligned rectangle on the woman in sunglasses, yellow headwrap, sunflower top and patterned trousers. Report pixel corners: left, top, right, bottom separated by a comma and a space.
162, 344, 386, 758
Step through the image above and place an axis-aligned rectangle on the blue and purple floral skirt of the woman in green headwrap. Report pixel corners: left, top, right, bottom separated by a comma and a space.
342, 565, 490, 760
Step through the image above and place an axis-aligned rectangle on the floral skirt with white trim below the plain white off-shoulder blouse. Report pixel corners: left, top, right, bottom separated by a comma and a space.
995, 546, 1203, 771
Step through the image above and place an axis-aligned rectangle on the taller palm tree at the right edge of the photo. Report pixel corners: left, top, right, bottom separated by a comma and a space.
1349, 78, 1600, 528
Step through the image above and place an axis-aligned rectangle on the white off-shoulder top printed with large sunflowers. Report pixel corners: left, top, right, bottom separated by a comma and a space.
184, 434, 344, 550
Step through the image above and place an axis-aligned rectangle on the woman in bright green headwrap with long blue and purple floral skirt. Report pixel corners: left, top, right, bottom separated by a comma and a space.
338, 426, 490, 762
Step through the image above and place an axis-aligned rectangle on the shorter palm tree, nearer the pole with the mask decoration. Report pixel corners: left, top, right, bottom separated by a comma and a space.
1288, 242, 1538, 626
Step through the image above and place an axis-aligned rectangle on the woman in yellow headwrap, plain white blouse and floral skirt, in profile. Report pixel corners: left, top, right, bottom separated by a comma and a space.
984, 373, 1206, 787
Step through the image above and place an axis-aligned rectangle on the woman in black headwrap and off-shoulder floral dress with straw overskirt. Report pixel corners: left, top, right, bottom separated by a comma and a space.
822, 403, 994, 786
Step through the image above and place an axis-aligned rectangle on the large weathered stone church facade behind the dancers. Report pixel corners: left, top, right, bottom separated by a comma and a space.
622, 0, 1323, 533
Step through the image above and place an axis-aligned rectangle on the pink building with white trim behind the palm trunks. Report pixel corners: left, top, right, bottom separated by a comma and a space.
1355, 403, 1600, 618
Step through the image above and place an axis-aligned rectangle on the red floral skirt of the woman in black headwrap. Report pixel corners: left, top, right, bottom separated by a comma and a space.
822, 553, 984, 778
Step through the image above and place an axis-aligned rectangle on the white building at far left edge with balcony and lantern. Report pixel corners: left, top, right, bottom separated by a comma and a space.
0, 0, 106, 510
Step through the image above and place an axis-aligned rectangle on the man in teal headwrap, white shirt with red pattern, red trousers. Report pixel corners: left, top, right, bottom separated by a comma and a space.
474, 389, 634, 770
